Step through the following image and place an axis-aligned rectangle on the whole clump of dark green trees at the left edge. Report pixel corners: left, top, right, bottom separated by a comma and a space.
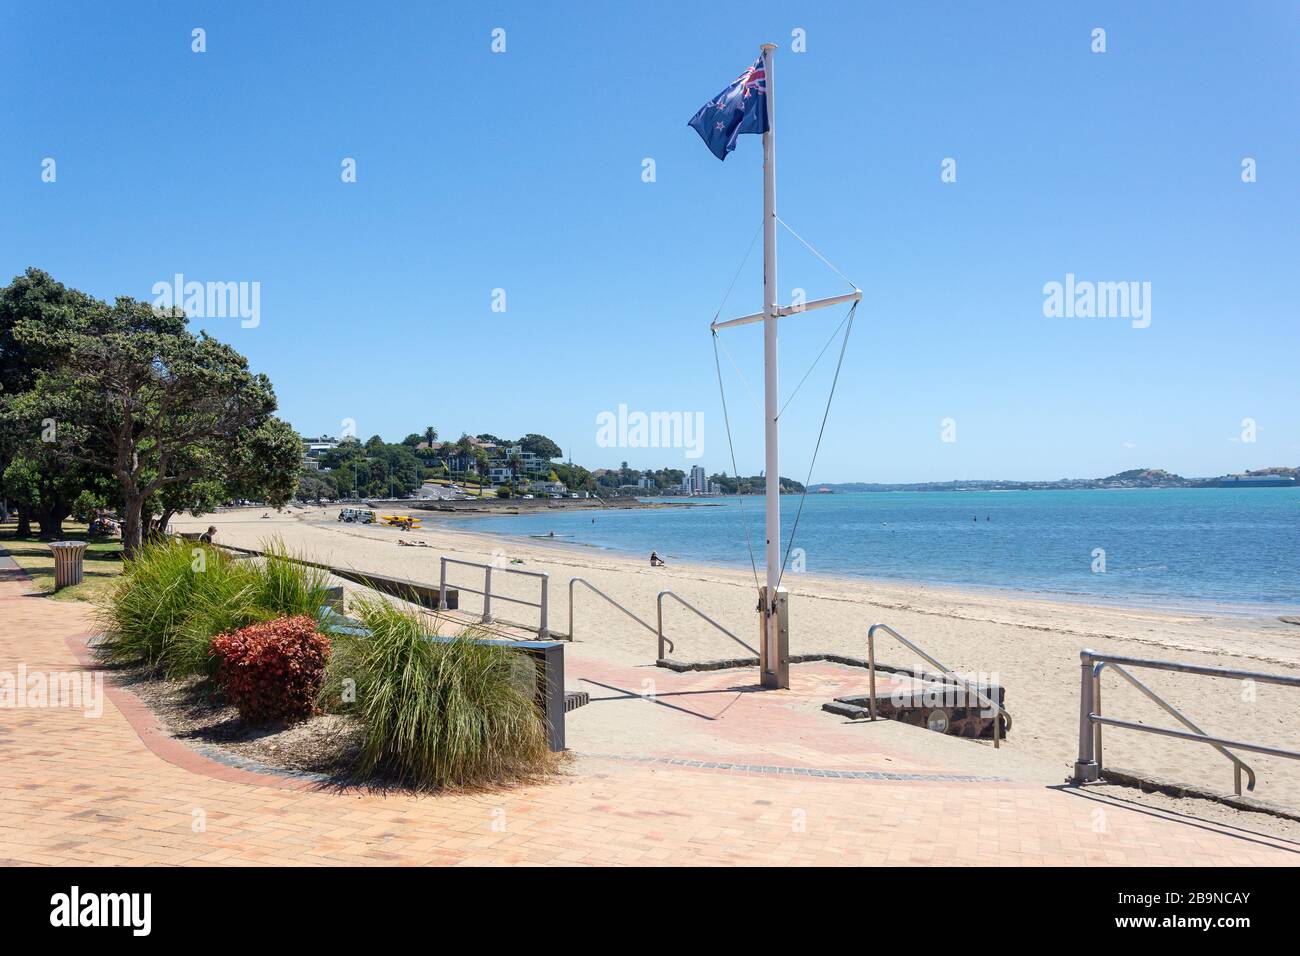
0, 269, 302, 555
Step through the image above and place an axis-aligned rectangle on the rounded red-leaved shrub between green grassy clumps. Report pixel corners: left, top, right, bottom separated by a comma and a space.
212, 615, 329, 723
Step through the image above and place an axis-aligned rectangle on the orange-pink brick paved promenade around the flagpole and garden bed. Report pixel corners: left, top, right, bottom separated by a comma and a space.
0, 561, 1300, 866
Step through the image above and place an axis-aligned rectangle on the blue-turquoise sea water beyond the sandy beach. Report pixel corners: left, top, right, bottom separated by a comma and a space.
439, 488, 1300, 611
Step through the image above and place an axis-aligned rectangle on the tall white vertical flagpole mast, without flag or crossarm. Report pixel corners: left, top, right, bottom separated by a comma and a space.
758, 43, 789, 687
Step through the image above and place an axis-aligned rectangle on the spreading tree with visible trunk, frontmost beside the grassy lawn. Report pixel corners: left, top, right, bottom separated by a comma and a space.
18, 298, 289, 557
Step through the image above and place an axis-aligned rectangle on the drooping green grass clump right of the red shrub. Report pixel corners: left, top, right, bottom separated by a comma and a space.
322, 598, 556, 790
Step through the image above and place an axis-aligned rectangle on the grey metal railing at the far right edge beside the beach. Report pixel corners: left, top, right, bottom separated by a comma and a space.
1073, 649, 1300, 796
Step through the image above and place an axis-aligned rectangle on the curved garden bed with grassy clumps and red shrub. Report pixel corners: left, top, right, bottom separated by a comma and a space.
95, 541, 563, 791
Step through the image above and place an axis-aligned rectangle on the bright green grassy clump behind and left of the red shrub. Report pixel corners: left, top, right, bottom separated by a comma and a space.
101, 540, 329, 676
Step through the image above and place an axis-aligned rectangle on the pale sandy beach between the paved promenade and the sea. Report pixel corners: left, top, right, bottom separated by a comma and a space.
173, 506, 1300, 808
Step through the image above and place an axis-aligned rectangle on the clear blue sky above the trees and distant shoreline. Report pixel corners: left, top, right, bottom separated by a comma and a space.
0, 3, 1300, 481
